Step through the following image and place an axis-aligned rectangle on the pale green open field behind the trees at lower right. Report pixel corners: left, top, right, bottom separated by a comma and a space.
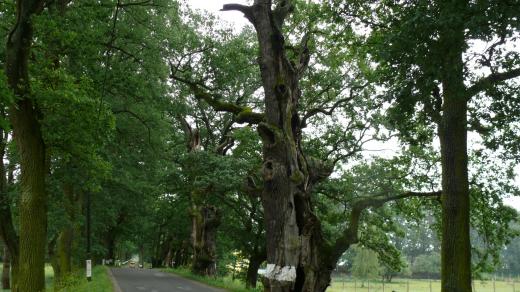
327, 278, 520, 292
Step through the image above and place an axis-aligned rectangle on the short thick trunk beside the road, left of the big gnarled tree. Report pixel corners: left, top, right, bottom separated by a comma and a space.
191, 205, 220, 276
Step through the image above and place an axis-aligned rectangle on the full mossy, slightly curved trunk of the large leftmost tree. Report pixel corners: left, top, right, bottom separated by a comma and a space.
6, 0, 47, 292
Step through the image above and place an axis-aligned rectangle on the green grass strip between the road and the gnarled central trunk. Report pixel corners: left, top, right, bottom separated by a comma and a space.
163, 268, 263, 292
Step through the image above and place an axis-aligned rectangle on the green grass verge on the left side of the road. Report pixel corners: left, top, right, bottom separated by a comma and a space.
0, 265, 113, 292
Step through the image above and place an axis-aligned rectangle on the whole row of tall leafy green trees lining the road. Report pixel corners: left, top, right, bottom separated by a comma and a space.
0, 0, 520, 292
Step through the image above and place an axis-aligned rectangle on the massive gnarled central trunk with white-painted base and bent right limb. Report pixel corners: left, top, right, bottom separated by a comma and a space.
219, 0, 440, 292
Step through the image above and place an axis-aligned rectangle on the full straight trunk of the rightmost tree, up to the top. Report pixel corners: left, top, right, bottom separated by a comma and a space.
439, 1, 471, 292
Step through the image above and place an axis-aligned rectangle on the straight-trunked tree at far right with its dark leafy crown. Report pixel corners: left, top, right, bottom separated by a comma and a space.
336, 0, 520, 292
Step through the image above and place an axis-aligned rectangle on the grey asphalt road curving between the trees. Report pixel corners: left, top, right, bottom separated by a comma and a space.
111, 268, 224, 292
